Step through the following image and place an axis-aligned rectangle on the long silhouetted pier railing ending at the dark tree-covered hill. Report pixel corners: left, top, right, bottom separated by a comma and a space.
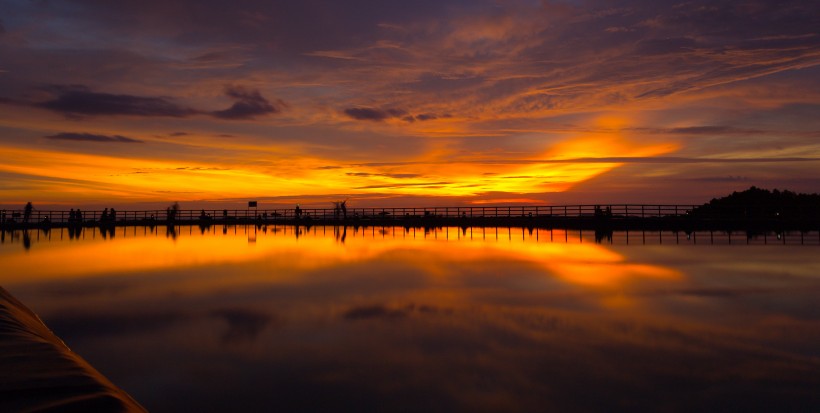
0, 204, 712, 223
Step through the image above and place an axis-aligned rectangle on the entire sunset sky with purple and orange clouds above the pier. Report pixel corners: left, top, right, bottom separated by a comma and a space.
0, 0, 820, 208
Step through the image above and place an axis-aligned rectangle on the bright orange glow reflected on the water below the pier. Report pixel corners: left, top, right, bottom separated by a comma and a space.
0, 226, 681, 296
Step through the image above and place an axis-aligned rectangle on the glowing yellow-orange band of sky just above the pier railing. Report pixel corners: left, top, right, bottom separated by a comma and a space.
0, 113, 677, 202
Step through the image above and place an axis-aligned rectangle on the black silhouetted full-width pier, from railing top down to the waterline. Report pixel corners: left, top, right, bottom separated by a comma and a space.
0, 204, 820, 233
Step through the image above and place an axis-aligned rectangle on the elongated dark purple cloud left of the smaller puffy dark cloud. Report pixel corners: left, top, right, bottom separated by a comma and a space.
35, 86, 198, 118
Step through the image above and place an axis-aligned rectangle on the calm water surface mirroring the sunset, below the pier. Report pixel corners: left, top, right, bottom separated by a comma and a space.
0, 226, 820, 412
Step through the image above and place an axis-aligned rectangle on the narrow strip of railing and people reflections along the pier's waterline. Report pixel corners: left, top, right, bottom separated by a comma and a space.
0, 223, 820, 249
